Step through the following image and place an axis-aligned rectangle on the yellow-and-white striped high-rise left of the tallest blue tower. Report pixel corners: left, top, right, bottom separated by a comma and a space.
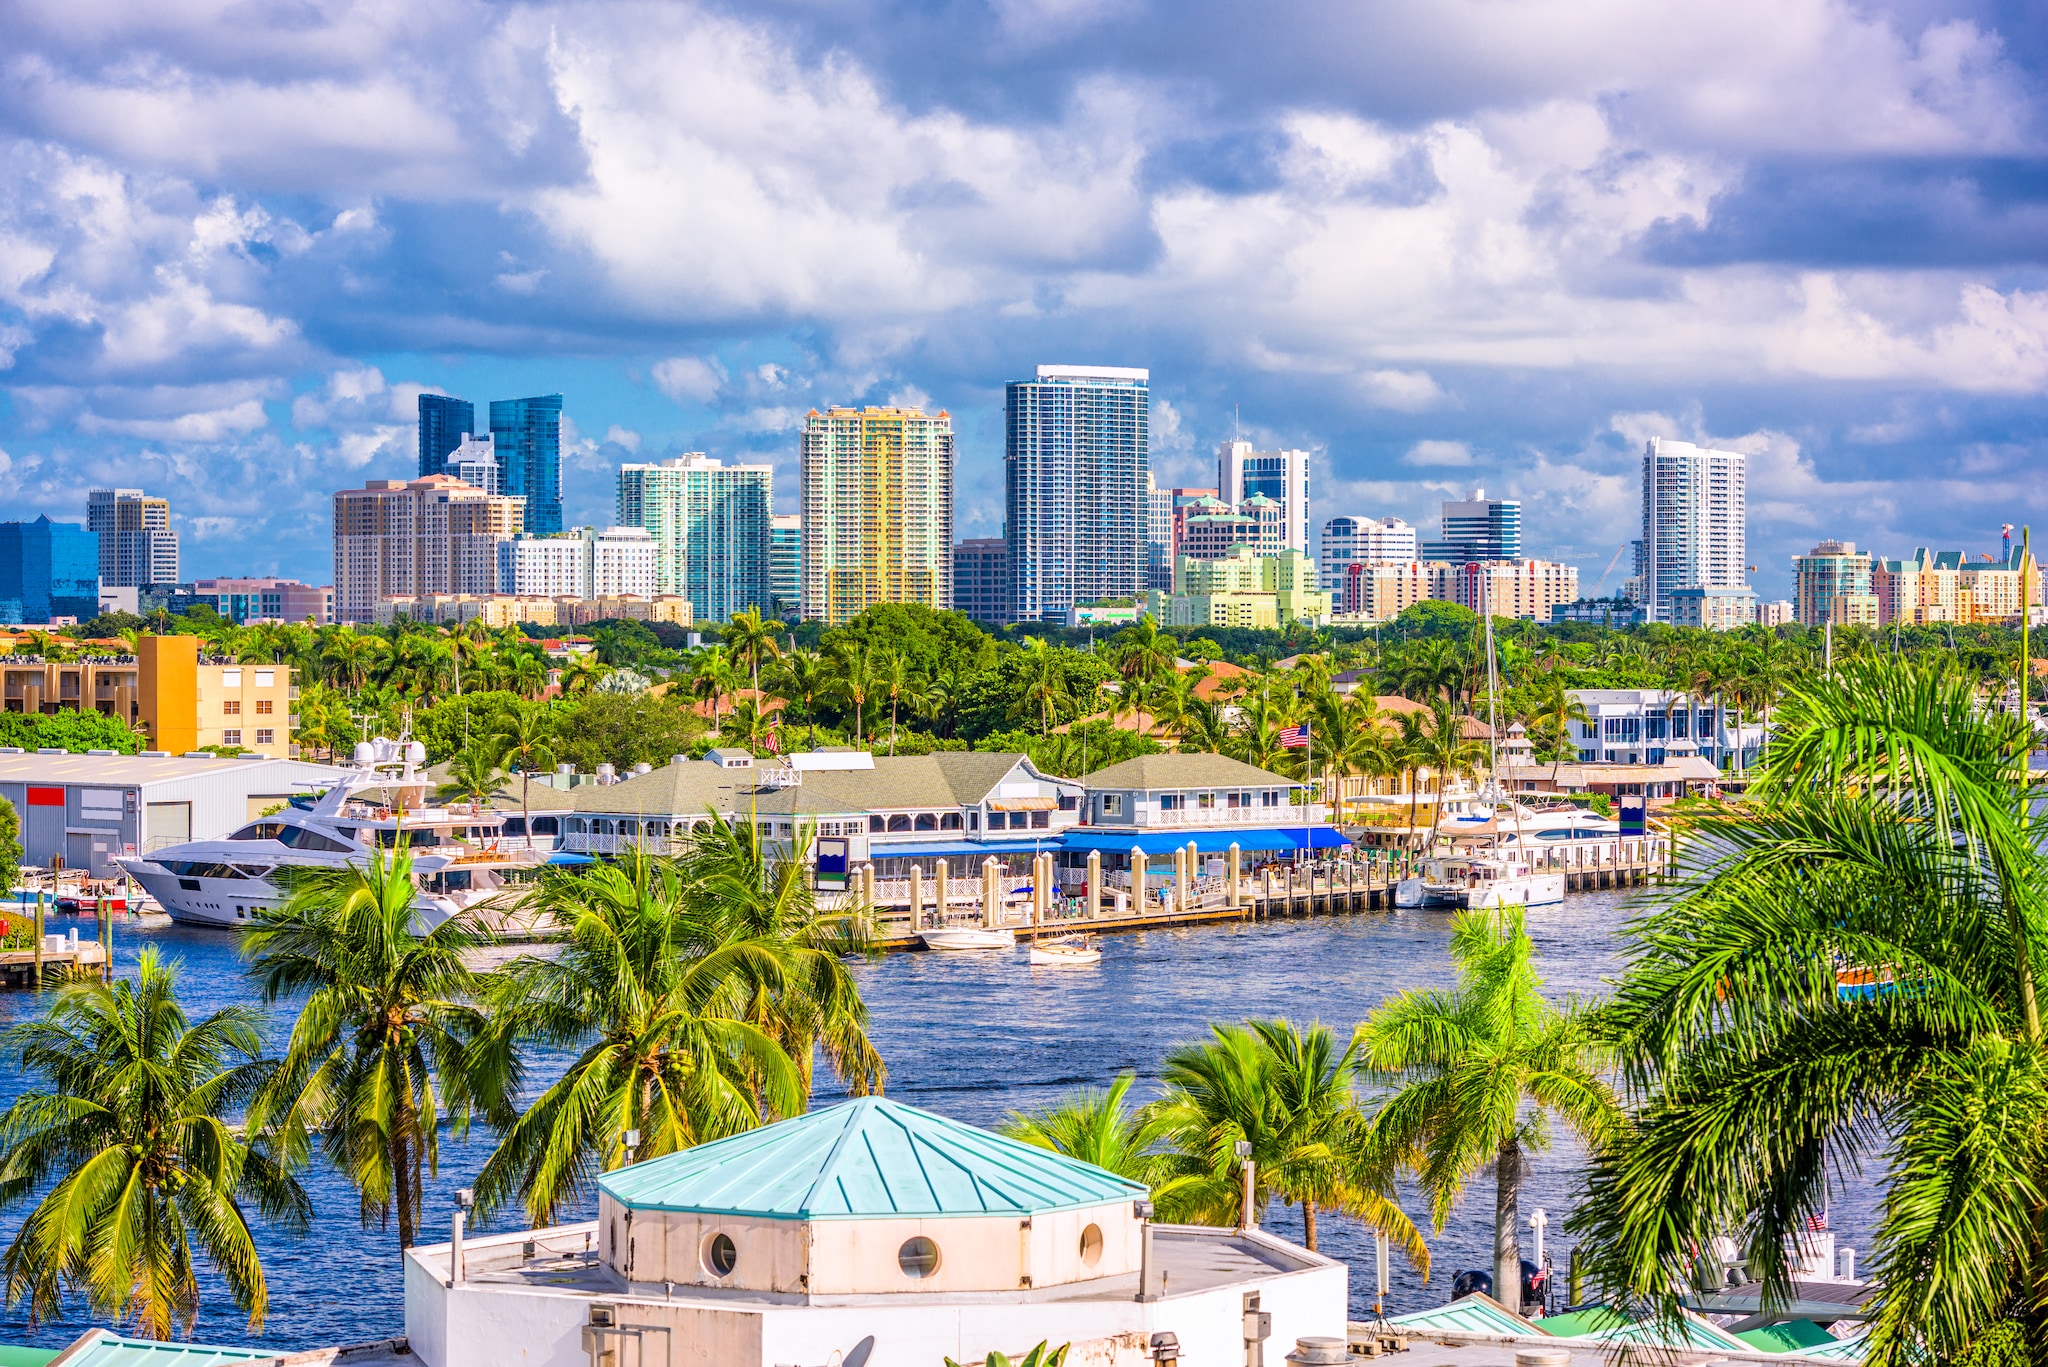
803, 408, 954, 623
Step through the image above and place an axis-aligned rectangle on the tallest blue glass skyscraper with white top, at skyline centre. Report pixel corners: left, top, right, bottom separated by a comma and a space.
1004, 365, 1151, 621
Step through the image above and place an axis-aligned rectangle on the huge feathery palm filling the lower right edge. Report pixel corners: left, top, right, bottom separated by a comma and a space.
1577, 656, 2048, 1367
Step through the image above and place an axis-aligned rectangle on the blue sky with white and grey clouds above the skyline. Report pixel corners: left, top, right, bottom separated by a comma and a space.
0, 0, 2048, 598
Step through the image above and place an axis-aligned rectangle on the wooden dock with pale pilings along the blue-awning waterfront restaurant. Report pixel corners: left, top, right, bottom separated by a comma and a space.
870, 836, 1669, 949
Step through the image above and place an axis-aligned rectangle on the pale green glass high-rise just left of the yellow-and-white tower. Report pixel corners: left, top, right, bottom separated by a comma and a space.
618, 451, 774, 623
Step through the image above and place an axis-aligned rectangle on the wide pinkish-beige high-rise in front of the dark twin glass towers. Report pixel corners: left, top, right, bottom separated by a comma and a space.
334, 475, 522, 623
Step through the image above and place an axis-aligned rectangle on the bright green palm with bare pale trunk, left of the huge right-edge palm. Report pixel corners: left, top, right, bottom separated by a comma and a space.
1354, 906, 1620, 1310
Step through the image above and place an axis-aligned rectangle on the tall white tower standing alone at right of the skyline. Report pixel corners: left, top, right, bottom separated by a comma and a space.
1630, 437, 1749, 621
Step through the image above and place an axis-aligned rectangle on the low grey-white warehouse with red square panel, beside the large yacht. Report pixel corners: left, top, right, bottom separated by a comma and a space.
0, 737, 340, 877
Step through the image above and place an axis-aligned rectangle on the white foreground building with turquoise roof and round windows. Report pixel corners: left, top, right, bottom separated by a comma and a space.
403, 1096, 1348, 1367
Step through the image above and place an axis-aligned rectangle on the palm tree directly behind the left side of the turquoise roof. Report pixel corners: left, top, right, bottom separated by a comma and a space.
477, 846, 805, 1226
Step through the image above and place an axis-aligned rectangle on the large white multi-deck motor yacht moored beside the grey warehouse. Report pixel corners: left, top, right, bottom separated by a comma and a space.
119, 738, 549, 935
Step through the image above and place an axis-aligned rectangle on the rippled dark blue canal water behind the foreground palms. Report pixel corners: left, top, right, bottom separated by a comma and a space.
0, 894, 1876, 1351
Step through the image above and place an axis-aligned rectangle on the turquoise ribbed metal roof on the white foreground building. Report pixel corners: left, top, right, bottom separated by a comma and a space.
598, 1096, 1147, 1219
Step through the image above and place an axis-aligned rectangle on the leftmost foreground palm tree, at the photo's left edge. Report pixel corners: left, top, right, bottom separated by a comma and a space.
0, 947, 313, 1338
